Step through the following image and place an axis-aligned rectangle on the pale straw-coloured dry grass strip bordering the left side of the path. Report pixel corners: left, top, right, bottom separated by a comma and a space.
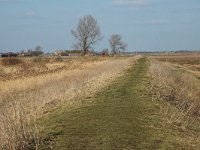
0, 58, 137, 149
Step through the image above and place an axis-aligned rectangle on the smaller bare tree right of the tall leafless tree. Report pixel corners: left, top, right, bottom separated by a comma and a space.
109, 34, 127, 54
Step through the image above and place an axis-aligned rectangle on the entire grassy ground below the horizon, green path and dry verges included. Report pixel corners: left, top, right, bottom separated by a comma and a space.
0, 55, 200, 150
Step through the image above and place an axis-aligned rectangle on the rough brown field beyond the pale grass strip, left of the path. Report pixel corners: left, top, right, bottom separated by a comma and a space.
0, 57, 109, 81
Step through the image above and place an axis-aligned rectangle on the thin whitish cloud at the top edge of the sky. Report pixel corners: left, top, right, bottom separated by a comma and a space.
113, 0, 152, 6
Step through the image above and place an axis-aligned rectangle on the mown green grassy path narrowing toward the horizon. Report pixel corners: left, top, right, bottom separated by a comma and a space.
39, 58, 197, 150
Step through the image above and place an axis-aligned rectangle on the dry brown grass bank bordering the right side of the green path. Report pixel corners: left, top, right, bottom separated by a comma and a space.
149, 60, 200, 128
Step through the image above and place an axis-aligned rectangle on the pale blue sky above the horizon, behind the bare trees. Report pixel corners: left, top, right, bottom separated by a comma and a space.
0, 0, 200, 52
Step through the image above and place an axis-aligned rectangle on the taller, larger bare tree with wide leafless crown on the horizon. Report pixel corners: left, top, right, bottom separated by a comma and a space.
71, 15, 102, 55
